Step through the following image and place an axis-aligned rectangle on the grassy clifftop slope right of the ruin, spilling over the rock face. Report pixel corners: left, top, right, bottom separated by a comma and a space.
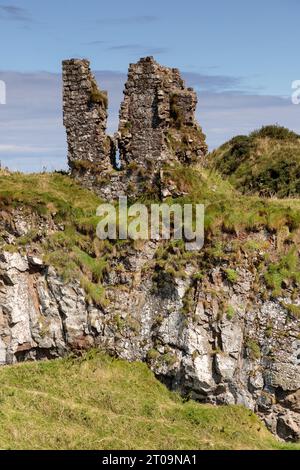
161, 163, 300, 297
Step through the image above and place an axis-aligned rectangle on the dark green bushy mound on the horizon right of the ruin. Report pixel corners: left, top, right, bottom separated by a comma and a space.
208, 126, 300, 197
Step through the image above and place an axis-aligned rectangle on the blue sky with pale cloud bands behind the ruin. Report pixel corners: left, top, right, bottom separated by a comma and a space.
0, 0, 300, 171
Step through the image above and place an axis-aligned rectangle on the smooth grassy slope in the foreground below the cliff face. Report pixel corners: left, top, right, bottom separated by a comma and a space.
0, 351, 300, 450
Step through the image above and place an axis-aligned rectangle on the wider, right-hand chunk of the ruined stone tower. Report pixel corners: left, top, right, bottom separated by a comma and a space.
119, 57, 207, 168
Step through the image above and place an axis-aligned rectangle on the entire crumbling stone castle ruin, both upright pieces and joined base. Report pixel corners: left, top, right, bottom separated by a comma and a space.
63, 57, 207, 199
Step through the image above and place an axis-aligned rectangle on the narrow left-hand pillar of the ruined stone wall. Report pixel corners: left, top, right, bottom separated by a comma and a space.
63, 59, 113, 178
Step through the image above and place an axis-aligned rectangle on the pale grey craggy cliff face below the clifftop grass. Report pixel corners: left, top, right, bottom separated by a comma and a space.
0, 250, 300, 440
